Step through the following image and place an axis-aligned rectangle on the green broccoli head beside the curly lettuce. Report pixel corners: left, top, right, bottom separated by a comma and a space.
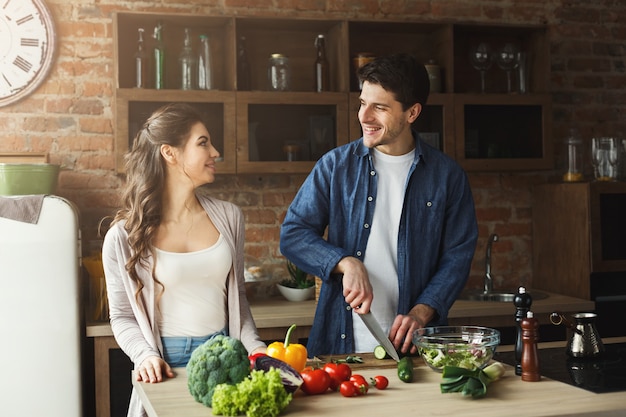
187, 335, 250, 407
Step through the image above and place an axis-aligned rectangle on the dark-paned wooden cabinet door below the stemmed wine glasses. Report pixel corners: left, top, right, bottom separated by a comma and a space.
454, 94, 554, 171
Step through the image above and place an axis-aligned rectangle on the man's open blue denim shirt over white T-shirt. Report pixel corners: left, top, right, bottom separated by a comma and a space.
280, 134, 478, 357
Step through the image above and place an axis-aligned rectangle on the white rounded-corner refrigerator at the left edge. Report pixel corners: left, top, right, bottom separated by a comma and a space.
0, 196, 82, 417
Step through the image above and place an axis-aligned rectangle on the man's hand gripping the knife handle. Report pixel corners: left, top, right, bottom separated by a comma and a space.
333, 256, 374, 314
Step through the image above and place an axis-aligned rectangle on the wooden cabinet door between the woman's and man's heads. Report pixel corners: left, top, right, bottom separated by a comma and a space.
237, 92, 348, 174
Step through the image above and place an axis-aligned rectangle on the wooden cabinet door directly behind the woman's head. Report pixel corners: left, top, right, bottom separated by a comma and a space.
115, 89, 236, 174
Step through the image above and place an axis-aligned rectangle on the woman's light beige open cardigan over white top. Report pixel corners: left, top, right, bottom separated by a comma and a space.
102, 194, 265, 417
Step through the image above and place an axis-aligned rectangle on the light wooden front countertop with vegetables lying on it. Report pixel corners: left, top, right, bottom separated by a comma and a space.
133, 340, 626, 417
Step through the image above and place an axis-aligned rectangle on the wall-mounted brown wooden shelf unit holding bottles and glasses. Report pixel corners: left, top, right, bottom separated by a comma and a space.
114, 13, 554, 174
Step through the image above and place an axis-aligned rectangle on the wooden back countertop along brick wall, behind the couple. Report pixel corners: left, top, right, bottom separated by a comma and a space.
87, 293, 595, 337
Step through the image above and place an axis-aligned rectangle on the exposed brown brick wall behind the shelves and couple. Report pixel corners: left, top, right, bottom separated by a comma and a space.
0, 0, 626, 287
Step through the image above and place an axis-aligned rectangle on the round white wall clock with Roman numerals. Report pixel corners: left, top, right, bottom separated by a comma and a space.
0, 0, 56, 106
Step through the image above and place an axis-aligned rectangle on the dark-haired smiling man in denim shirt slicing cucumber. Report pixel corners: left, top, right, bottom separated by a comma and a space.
280, 54, 478, 355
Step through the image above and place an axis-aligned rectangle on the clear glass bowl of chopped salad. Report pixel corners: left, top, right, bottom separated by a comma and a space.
413, 326, 500, 372
